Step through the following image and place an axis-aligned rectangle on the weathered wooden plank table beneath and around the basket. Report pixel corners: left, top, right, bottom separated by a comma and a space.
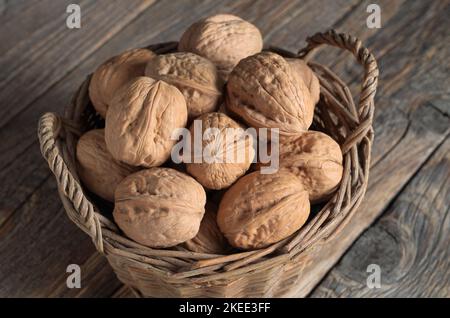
0, 0, 450, 297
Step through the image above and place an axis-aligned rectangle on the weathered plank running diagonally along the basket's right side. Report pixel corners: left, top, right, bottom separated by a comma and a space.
288, 1, 450, 296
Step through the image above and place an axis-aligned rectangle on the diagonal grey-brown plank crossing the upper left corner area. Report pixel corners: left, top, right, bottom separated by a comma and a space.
0, 0, 153, 127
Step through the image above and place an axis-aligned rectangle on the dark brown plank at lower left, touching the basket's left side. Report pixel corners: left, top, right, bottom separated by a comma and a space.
0, 178, 110, 297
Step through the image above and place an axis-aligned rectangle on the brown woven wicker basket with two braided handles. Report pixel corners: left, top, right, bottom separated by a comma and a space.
39, 30, 378, 297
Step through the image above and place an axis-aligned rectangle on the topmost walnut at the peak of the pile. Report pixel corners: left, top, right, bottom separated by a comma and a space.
178, 14, 263, 74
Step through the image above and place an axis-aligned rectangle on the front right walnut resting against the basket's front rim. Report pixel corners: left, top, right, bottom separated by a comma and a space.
217, 170, 310, 249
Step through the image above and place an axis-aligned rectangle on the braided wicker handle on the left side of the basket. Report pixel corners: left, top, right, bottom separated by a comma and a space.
38, 113, 103, 253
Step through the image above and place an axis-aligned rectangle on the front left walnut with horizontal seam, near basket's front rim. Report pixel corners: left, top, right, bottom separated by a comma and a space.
113, 168, 206, 247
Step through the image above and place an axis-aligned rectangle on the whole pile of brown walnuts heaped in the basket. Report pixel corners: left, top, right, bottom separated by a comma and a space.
77, 14, 343, 254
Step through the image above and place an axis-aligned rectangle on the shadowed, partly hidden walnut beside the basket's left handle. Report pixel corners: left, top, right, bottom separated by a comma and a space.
77, 129, 134, 202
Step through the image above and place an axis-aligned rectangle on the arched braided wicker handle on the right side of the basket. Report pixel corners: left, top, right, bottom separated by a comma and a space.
298, 30, 379, 152
